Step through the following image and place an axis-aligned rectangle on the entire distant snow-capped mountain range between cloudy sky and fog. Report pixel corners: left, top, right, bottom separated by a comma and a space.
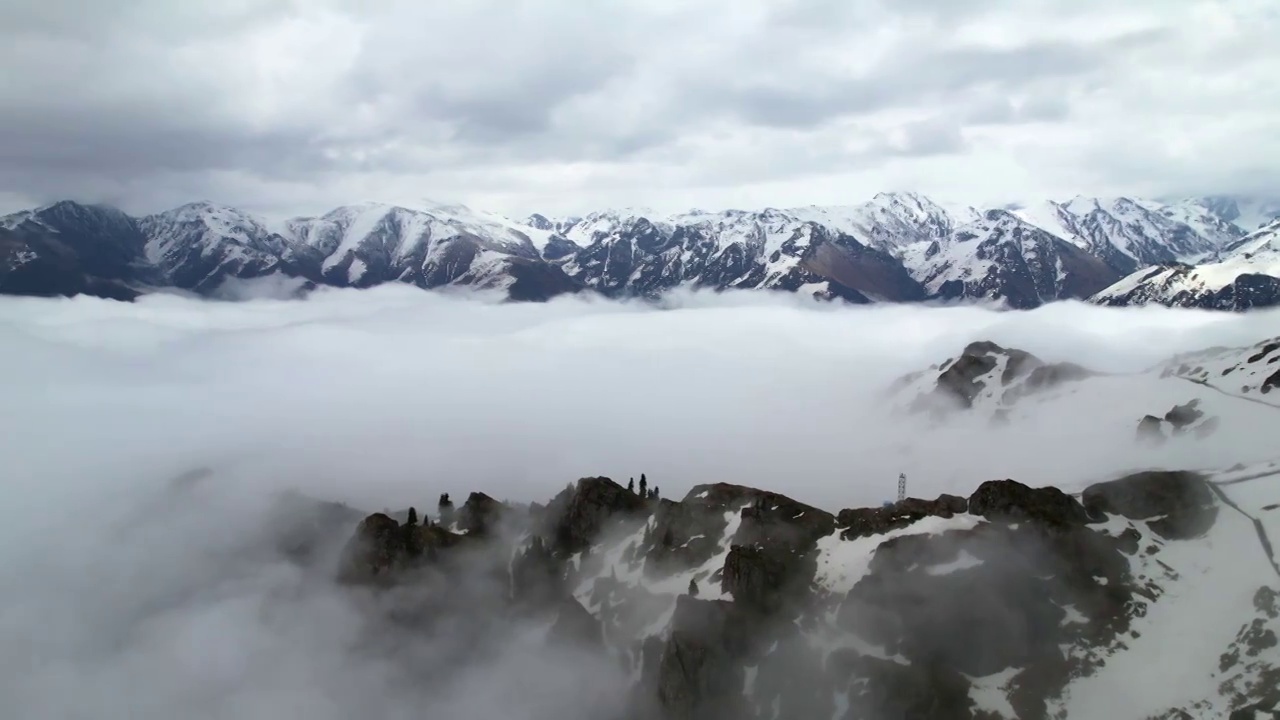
0, 192, 1280, 309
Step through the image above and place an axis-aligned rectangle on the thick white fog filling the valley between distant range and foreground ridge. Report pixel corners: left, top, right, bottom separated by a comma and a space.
0, 287, 1280, 720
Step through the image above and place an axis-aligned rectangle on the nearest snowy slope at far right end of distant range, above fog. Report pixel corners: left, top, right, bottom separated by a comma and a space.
1092, 220, 1280, 310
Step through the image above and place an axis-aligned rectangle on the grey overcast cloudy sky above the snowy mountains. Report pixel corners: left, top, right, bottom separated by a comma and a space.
0, 0, 1280, 215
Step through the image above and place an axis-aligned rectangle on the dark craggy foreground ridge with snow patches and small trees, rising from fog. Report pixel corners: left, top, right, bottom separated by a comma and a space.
309, 456, 1280, 720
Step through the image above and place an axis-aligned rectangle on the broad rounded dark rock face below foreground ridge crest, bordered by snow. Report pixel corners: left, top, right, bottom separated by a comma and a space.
840, 512, 1134, 717
